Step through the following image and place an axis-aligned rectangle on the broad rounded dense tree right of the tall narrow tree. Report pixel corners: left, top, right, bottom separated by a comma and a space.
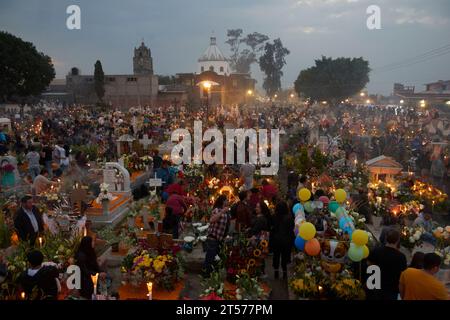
295, 56, 370, 104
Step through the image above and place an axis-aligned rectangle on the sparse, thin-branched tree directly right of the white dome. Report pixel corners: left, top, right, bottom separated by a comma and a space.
225, 29, 269, 73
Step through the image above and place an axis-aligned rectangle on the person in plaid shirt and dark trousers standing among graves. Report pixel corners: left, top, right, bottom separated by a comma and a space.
203, 195, 230, 276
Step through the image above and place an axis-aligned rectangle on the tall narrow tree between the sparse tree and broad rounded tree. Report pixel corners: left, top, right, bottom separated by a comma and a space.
259, 38, 290, 97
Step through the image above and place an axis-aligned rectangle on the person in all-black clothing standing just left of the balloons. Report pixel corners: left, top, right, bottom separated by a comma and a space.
270, 202, 295, 279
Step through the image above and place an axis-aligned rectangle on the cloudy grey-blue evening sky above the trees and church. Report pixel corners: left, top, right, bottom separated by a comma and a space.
0, 0, 450, 94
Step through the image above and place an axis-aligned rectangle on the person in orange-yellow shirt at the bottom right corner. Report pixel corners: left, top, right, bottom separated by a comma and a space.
400, 253, 449, 300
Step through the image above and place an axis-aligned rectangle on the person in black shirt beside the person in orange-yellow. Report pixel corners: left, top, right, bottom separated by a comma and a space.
367, 229, 407, 300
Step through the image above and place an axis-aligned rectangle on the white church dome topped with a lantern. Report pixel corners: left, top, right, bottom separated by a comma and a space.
198, 37, 230, 76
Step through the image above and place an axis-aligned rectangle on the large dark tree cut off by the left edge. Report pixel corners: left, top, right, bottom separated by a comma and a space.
0, 31, 55, 100
